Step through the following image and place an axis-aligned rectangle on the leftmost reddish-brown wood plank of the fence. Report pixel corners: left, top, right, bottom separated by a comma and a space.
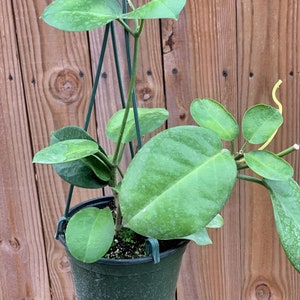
0, 1, 50, 300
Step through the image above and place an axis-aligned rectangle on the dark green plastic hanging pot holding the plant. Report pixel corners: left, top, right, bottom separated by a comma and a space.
59, 197, 187, 300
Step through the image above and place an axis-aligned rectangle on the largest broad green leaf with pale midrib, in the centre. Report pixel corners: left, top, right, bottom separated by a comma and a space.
120, 126, 237, 239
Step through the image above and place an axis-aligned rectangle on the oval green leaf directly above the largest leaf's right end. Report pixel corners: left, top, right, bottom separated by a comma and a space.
190, 99, 239, 141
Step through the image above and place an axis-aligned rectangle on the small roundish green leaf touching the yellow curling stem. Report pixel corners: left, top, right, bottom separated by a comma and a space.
242, 104, 283, 144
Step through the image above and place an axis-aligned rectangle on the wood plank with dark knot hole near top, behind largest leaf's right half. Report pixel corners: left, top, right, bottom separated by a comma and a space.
162, 1, 242, 300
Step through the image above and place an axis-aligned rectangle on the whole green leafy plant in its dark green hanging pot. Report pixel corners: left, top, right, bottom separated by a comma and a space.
33, 0, 300, 300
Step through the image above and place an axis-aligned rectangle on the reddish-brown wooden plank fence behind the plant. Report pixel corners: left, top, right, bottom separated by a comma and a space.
0, 0, 300, 300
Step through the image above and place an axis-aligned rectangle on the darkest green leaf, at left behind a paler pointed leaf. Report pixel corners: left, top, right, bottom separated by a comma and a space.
50, 126, 107, 189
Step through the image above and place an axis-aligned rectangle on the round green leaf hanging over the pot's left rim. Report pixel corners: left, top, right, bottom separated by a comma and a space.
66, 207, 114, 263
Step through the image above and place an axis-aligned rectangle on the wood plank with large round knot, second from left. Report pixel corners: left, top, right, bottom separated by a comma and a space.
13, 0, 97, 299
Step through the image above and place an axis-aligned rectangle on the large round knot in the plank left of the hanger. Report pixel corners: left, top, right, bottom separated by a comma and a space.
51, 69, 81, 103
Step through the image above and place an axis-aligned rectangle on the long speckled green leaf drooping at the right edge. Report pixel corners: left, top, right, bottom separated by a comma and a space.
265, 179, 300, 272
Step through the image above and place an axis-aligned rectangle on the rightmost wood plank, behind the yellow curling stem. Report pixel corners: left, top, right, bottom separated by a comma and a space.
238, 1, 300, 300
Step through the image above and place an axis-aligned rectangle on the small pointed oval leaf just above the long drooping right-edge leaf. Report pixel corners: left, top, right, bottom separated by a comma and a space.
244, 150, 294, 181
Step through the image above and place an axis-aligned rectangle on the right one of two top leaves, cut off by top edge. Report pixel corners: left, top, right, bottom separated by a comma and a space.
122, 0, 186, 20
